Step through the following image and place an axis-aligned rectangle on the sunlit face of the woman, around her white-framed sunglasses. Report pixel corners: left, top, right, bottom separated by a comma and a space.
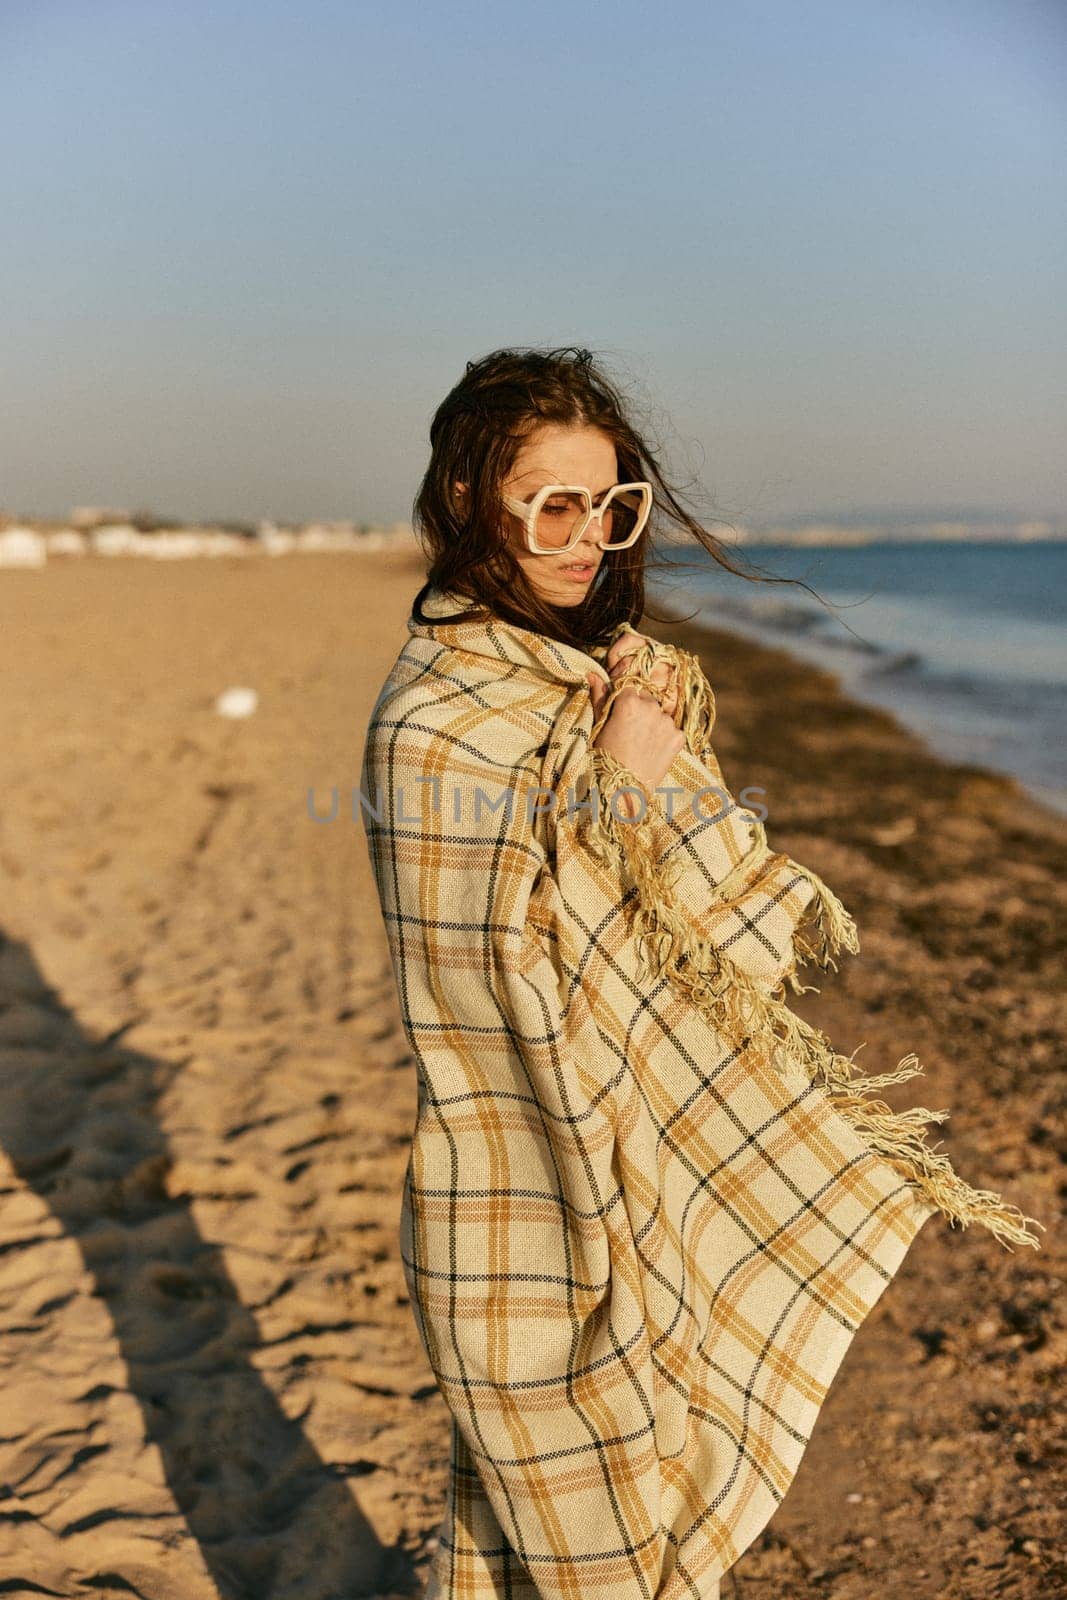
504, 422, 617, 605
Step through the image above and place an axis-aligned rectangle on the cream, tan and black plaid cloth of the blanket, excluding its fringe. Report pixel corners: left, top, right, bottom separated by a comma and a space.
360, 594, 933, 1600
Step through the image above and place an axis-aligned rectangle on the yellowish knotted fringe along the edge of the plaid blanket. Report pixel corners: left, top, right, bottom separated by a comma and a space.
584, 624, 1045, 1251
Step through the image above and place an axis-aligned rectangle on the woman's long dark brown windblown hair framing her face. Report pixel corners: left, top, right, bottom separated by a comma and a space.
411, 346, 819, 650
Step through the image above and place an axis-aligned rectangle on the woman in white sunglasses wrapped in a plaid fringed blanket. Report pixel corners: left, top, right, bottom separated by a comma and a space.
362, 350, 1041, 1600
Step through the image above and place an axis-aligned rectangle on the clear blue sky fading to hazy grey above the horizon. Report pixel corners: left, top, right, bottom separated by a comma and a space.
0, 0, 1067, 520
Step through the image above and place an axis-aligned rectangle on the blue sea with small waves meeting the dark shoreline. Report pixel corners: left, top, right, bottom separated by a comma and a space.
646, 539, 1067, 816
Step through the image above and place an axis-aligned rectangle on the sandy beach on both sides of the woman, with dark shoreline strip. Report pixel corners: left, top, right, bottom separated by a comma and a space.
0, 549, 1067, 1600
